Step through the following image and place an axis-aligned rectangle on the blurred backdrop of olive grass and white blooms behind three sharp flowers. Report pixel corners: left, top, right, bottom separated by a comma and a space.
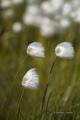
0, 0, 80, 119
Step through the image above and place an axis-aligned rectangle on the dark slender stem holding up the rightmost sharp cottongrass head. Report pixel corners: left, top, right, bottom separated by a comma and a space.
42, 57, 57, 109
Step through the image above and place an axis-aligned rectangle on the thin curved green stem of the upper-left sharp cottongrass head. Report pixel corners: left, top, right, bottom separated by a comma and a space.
5, 55, 28, 116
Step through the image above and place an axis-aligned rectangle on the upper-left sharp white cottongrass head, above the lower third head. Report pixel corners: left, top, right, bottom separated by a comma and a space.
27, 42, 45, 58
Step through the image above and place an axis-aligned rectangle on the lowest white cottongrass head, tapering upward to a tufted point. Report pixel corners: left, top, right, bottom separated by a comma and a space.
21, 68, 39, 90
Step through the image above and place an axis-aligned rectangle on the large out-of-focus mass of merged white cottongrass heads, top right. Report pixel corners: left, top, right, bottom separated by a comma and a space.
23, 0, 80, 37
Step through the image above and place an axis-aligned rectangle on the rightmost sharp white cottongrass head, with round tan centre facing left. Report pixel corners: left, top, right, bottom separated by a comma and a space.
55, 42, 74, 59
